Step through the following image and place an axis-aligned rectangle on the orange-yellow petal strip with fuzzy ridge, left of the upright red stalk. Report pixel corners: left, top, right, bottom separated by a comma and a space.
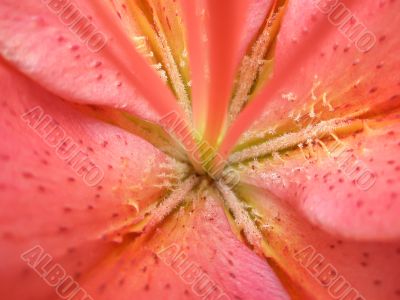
114, 0, 191, 122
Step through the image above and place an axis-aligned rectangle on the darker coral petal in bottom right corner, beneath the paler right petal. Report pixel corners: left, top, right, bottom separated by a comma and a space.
239, 187, 400, 300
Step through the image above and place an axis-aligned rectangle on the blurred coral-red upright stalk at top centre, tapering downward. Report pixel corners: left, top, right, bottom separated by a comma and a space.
183, 1, 250, 144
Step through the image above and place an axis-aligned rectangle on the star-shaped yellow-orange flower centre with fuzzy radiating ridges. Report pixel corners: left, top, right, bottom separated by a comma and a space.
105, 0, 400, 253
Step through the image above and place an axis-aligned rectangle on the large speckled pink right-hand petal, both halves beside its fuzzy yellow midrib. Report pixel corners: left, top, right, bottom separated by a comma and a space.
227, 1, 400, 240
